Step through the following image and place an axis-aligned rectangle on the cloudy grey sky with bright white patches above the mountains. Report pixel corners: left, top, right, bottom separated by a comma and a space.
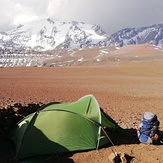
0, 0, 163, 34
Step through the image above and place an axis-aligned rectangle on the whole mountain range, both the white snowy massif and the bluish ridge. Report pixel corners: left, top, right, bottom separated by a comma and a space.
0, 19, 163, 54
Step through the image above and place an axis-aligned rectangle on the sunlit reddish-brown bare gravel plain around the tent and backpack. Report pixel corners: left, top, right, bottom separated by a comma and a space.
0, 44, 163, 163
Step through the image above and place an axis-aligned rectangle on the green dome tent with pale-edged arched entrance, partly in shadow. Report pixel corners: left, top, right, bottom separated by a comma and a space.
11, 95, 121, 159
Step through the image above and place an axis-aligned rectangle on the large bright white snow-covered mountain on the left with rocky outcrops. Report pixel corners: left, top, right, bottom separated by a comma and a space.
0, 19, 106, 51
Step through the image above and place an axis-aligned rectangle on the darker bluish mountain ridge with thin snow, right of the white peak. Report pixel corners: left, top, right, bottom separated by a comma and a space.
106, 24, 163, 47
